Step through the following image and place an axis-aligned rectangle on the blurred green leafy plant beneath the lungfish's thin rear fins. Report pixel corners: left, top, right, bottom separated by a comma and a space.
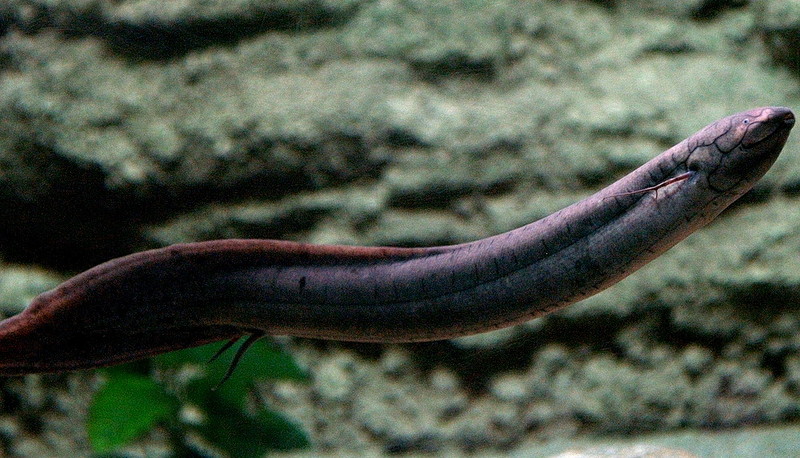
87, 340, 308, 457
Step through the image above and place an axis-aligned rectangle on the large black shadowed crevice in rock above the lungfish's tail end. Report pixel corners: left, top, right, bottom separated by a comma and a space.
0, 132, 385, 272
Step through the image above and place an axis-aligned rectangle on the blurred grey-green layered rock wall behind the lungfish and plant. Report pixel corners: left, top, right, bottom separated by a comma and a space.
0, 0, 800, 456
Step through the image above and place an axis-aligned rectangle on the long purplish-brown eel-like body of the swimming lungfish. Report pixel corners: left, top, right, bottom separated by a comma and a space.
0, 107, 794, 375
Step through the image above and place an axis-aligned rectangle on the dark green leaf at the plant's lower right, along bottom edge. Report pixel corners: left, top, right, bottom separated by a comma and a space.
199, 404, 309, 458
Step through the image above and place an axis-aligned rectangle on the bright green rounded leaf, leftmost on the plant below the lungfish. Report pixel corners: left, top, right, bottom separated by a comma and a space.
87, 372, 179, 453
